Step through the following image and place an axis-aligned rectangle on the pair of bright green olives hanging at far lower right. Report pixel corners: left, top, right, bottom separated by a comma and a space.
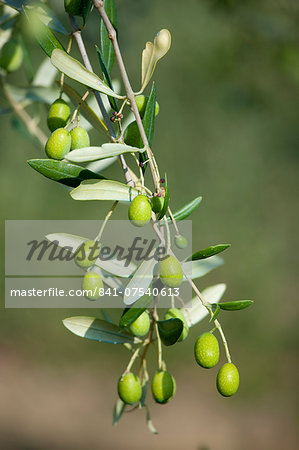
194, 332, 240, 397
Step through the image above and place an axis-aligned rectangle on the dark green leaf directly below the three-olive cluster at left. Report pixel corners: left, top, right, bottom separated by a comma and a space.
27, 159, 105, 187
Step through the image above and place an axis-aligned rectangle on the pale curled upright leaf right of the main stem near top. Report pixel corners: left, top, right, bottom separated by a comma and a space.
140, 29, 171, 93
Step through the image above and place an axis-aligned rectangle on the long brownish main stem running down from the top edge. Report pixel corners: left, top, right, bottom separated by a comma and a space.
93, 0, 160, 192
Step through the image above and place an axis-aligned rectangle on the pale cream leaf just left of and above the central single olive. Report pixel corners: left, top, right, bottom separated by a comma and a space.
70, 180, 139, 202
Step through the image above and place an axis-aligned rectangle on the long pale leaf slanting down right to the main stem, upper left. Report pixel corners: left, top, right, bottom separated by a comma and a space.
51, 49, 124, 99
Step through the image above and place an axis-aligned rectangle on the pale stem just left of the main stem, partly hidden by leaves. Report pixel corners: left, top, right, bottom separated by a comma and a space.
69, 14, 134, 186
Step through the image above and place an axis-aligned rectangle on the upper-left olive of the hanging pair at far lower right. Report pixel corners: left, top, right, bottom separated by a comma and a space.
194, 333, 219, 369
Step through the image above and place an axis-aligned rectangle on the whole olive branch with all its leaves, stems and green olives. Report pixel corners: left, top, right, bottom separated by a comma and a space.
0, 0, 252, 433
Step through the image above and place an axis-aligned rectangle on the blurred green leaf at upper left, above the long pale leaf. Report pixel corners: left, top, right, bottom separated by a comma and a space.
25, 8, 65, 57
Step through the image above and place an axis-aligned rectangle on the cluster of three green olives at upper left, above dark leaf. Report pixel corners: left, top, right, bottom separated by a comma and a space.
45, 98, 90, 160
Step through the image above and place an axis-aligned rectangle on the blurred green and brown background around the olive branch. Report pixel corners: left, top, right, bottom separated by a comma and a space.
0, 0, 299, 450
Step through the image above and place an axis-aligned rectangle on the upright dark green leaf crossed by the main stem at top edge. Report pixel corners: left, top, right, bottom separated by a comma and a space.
100, 0, 117, 73
